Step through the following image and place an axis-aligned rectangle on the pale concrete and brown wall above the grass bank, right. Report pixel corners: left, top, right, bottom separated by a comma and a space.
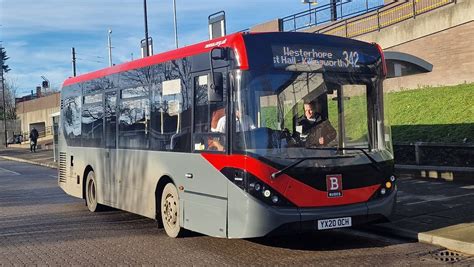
355, 0, 474, 90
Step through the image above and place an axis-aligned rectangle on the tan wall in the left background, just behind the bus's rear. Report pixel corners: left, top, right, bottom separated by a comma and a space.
16, 93, 61, 136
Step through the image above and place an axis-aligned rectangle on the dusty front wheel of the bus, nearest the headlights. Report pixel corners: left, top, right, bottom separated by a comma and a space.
161, 183, 182, 238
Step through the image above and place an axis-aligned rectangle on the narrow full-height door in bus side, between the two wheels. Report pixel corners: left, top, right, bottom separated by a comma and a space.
104, 91, 119, 206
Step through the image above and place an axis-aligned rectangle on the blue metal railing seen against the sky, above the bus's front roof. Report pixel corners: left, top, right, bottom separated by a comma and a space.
281, 0, 382, 32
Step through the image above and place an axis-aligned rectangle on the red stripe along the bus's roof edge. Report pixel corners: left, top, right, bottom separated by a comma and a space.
63, 33, 249, 87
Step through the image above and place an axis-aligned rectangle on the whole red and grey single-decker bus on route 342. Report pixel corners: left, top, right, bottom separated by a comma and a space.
58, 32, 397, 238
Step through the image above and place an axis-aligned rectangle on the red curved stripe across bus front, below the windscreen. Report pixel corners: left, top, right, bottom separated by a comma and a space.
202, 153, 380, 208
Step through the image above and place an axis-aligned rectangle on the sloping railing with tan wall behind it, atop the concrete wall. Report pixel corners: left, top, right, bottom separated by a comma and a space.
314, 0, 457, 38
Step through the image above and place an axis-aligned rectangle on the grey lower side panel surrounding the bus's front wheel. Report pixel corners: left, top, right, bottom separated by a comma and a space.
116, 149, 227, 237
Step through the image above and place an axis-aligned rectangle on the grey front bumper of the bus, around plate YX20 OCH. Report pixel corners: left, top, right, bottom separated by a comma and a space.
228, 187, 397, 238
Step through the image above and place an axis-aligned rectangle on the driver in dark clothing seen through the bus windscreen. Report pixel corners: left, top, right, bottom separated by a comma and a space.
298, 101, 337, 146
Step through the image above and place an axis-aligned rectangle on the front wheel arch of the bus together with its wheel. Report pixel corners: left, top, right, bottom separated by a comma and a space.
155, 176, 183, 238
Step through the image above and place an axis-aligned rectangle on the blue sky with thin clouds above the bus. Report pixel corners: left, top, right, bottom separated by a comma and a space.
0, 0, 382, 96
